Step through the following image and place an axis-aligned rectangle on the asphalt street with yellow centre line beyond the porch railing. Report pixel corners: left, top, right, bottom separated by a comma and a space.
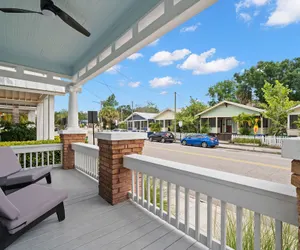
143, 141, 291, 184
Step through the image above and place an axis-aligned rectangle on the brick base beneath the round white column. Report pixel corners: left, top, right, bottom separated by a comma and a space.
60, 131, 86, 169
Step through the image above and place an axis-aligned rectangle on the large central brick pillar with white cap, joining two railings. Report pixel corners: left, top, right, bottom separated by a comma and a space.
97, 132, 145, 205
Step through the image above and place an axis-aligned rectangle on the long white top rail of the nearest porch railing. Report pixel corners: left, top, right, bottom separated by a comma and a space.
124, 155, 297, 225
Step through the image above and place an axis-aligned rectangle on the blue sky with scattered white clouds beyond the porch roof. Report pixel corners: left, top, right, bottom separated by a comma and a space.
55, 0, 300, 111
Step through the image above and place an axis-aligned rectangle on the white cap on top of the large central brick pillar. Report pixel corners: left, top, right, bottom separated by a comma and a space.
95, 132, 148, 141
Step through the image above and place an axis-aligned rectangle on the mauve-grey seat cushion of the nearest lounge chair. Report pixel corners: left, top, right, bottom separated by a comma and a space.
0, 184, 68, 234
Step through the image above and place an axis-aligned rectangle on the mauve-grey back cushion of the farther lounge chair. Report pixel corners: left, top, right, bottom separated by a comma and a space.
0, 147, 22, 178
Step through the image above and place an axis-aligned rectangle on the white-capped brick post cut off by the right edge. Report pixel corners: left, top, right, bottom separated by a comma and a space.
281, 138, 300, 250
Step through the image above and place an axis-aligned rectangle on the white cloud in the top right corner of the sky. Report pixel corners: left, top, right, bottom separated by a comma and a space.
266, 0, 300, 26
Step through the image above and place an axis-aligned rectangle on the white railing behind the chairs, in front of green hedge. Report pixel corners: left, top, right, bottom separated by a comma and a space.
11, 143, 63, 169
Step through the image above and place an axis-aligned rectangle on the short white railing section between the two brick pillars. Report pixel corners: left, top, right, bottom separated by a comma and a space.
72, 143, 99, 181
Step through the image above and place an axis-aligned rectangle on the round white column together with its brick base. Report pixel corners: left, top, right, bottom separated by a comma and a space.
60, 88, 87, 169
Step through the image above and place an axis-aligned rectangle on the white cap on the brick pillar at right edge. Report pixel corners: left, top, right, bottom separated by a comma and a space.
281, 137, 300, 160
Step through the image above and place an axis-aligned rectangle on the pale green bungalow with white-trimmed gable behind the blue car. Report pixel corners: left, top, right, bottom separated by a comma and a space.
197, 101, 269, 140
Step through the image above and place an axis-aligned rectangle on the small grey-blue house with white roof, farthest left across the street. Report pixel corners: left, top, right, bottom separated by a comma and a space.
124, 112, 157, 131
